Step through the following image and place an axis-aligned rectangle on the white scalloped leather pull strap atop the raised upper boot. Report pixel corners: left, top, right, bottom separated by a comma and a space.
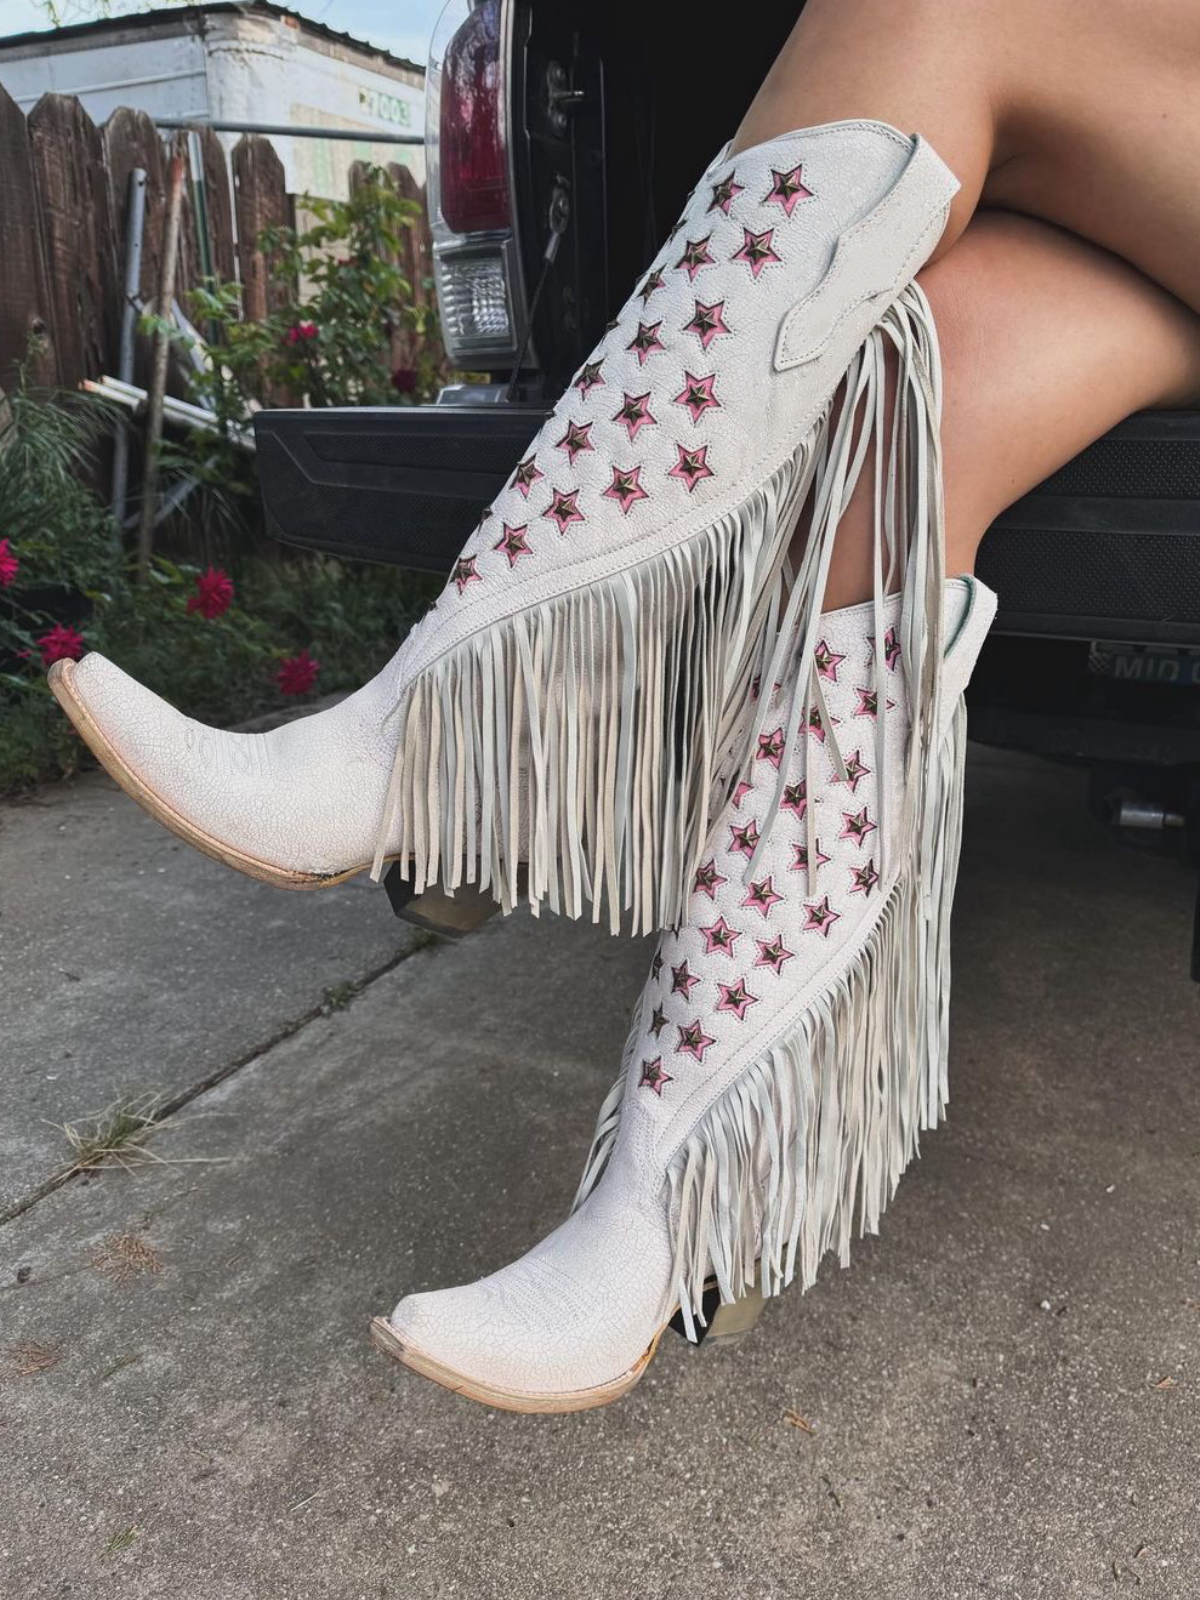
774, 134, 958, 373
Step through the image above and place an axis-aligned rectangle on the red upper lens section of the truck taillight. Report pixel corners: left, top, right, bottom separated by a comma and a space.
438, 0, 512, 234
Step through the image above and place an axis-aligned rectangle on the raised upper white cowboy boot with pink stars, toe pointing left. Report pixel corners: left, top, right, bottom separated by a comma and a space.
51, 122, 958, 930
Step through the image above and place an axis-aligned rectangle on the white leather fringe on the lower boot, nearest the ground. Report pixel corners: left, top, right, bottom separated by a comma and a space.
668, 701, 966, 1338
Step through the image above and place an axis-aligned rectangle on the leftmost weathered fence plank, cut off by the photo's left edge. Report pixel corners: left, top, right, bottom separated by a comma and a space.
0, 86, 58, 390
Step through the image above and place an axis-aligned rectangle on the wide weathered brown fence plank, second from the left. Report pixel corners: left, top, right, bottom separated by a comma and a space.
29, 94, 120, 389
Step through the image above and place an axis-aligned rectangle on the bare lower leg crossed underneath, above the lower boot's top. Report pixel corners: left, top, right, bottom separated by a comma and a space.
827, 211, 1200, 608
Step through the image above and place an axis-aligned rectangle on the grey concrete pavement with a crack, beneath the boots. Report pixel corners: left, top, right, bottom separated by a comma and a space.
0, 749, 1200, 1600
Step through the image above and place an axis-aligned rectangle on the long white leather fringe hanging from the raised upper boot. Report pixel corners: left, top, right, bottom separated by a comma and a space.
373, 285, 933, 933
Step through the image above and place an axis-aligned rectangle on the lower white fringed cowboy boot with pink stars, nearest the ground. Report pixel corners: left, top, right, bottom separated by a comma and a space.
373, 579, 995, 1411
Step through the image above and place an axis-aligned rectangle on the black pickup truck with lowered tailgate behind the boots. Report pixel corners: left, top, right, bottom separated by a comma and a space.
254, 0, 1200, 979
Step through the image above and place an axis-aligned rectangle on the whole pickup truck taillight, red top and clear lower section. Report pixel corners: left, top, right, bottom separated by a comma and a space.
426, 0, 526, 370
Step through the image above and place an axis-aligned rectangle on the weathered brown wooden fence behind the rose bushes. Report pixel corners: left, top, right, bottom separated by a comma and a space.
0, 86, 432, 403
